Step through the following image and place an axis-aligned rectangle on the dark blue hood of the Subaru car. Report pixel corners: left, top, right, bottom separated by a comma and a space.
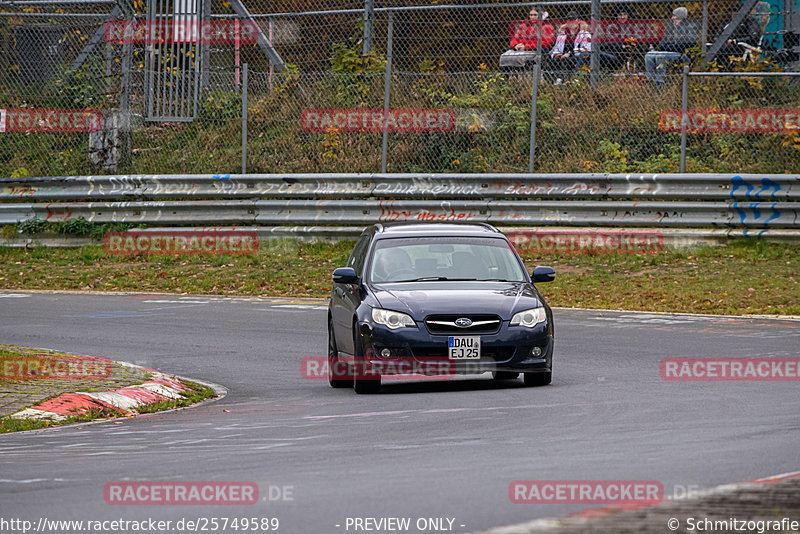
371, 282, 542, 321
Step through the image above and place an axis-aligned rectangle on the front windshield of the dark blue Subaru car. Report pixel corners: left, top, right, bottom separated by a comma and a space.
369, 237, 526, 283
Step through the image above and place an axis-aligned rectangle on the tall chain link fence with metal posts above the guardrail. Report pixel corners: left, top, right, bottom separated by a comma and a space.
0, 0, 800, 176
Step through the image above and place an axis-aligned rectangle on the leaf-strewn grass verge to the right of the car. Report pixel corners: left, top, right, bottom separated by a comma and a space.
524, 240, 800, 315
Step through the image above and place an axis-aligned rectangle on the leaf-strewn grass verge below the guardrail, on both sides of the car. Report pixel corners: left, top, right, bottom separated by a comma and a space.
0, 239, 800, 315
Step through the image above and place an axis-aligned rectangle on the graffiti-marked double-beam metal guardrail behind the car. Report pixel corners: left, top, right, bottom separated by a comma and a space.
0, 174, 800, 229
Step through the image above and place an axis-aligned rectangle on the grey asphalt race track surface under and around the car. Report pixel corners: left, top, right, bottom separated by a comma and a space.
0, 294, 800, 534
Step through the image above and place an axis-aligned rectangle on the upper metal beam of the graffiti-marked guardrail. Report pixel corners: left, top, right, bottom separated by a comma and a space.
0, 173, 800, 201
